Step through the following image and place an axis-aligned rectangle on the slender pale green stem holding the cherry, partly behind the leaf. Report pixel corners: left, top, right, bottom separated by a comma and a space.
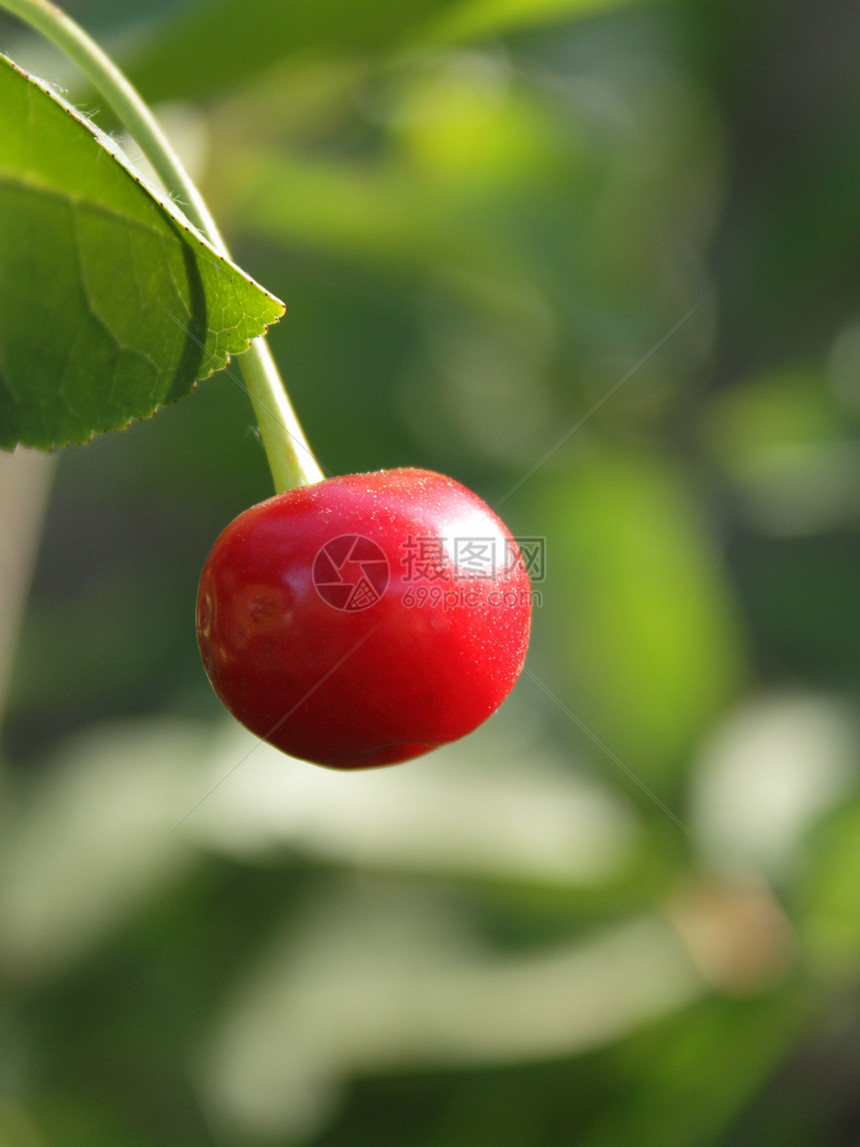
0, 0, 323, 493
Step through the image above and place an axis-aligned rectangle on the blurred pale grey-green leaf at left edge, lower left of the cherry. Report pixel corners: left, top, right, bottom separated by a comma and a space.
0, 719, 208, 981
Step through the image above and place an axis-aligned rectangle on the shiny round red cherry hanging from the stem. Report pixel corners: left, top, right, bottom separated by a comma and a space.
197, 469, 531, 768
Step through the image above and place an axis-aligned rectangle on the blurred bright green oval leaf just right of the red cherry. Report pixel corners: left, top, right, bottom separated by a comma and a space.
538, 448, 743, 777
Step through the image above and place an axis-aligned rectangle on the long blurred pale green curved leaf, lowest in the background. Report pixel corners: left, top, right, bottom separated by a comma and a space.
201, 880, 703, 1141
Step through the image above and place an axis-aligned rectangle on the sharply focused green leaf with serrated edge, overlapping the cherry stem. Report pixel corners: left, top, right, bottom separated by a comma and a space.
0, 56, 283, 450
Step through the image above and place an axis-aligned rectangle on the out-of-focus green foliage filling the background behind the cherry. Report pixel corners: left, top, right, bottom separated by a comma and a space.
0, 0, 860, 1147
